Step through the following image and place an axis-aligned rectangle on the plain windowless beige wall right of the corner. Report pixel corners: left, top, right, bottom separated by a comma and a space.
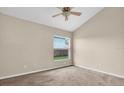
73, 8, 124, 76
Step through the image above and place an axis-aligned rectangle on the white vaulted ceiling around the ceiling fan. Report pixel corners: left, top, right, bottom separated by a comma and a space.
0, 7, 103, 32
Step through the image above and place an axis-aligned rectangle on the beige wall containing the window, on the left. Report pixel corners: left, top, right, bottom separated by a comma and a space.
0, 14, 72, 78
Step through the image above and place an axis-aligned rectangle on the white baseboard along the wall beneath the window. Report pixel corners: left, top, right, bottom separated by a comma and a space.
0, 65, 72, 80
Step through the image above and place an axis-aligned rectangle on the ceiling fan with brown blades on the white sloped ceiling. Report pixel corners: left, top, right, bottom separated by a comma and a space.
52, 7, 81, 21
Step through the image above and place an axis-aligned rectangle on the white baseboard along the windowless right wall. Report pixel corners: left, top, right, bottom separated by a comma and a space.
75, 65, 124, 79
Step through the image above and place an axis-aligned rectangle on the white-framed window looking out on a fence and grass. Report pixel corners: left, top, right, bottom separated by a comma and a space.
53, 36, 70, 61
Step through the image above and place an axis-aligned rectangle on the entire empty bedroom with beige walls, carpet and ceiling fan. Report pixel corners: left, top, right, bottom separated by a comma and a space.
0, 7, 124, 86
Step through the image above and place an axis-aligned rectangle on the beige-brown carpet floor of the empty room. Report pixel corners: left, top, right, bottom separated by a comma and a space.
0, 66, 124, 86
